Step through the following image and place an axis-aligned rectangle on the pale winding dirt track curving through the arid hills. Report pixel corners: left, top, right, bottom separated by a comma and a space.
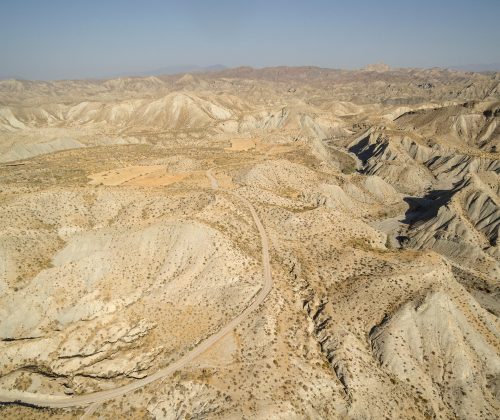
0, 170, 273, 408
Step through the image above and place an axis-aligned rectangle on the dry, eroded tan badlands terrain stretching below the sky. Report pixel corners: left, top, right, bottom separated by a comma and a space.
0, 65, 500, 419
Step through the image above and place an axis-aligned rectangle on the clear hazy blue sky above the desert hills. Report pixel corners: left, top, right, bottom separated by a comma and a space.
0, 0, 500, 80
